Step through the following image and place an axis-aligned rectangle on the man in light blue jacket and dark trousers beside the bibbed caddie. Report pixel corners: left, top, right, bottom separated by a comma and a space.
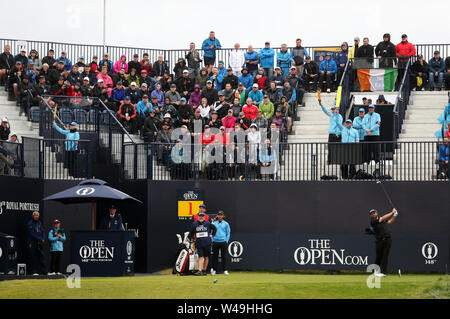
211, 210, 231, 276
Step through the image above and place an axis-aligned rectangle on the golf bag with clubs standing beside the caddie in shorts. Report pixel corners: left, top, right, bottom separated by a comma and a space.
172, 232, 198, 275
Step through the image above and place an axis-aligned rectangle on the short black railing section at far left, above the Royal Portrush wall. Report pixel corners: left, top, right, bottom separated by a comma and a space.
0, 137, 92, 180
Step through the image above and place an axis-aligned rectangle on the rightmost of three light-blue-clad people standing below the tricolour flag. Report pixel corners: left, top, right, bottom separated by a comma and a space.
363, 104, 381, 163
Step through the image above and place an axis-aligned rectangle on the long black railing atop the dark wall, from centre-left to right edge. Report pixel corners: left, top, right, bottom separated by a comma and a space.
122, 141, 448, 181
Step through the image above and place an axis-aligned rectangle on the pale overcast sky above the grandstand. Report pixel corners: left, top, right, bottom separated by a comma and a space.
0, 0, 450, 49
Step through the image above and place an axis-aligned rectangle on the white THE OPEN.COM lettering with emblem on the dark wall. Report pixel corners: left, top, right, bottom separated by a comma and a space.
294, 239, 368, 266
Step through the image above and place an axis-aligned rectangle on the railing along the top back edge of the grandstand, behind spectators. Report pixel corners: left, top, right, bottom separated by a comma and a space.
0, 39, 450, 71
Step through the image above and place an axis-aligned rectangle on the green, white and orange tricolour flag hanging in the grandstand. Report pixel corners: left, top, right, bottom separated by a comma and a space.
358, 69, 398, 92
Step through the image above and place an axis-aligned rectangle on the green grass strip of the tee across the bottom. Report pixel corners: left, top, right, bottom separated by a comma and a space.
0, 272, 450, 299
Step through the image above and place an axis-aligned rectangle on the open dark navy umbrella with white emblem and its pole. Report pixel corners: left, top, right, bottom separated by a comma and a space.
44, 179, 142, 230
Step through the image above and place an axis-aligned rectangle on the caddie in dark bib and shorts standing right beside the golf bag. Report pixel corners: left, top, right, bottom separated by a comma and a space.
189, 211, 217, 276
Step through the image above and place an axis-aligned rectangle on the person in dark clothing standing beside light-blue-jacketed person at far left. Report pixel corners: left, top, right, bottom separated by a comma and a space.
27, 211, 48, 276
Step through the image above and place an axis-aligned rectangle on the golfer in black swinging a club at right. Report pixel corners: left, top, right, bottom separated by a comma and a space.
369, 208, 398, 277
